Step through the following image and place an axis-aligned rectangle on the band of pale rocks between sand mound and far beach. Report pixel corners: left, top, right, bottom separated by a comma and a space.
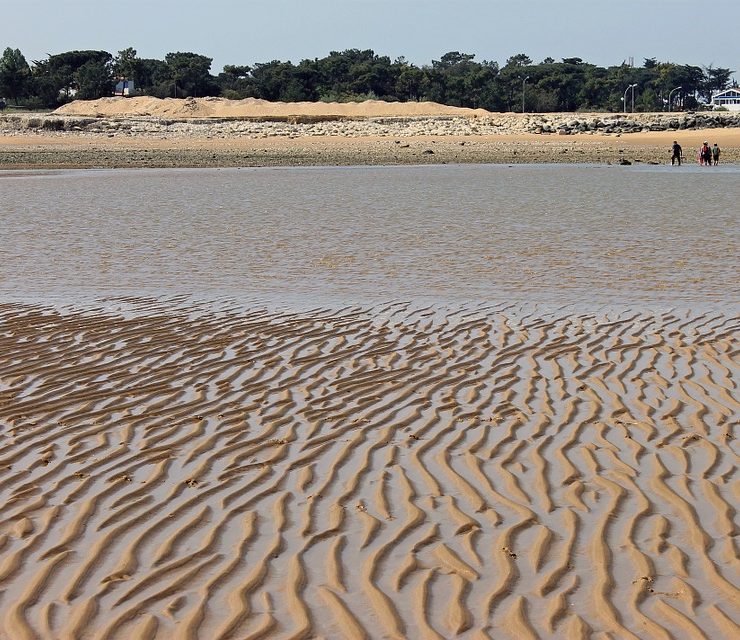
0, 112, 740, 139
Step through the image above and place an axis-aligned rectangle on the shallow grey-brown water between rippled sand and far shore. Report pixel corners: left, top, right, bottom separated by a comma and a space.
0, 165, 740, 303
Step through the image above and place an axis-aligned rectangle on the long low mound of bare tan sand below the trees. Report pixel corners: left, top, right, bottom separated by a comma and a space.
54, 97, 488, 118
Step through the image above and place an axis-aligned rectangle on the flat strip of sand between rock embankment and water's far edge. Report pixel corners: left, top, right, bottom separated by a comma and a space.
0, 129, 740, 169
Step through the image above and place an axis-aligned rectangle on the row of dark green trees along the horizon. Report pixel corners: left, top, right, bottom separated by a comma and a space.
0, 47, 734, 112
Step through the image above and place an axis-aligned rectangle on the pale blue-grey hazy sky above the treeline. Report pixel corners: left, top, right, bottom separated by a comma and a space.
5, 0, 740, 78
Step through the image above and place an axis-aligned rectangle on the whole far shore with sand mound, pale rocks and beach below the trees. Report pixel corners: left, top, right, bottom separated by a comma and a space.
0, 98, 740, 169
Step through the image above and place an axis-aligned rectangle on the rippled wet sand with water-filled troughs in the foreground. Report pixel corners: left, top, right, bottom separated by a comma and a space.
0, 299, 740, 640
